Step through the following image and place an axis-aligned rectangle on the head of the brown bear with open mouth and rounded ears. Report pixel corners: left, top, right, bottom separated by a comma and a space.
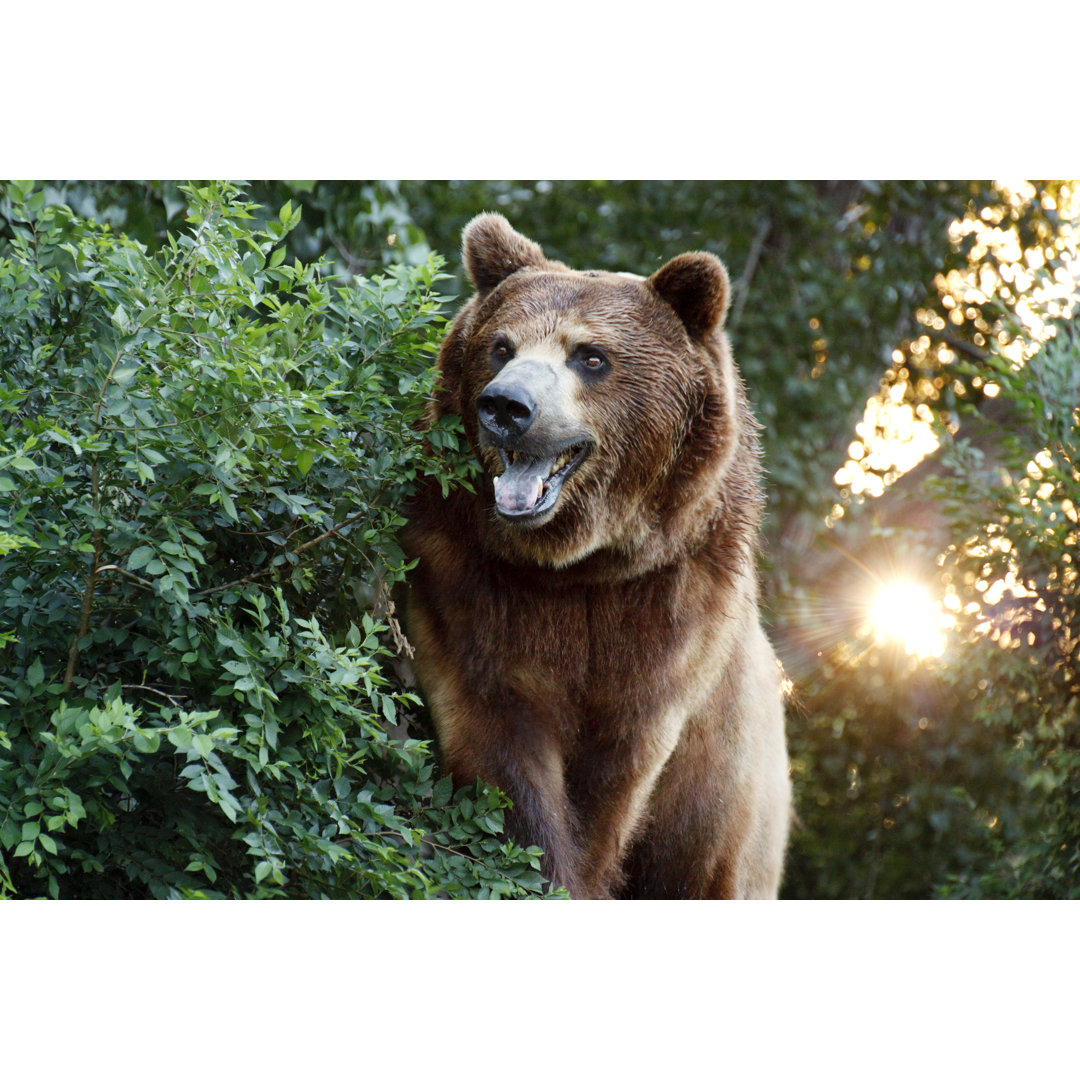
434, 214, 760, 572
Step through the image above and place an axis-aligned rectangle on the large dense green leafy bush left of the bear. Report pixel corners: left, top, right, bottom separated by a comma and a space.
0, 184, 548, 897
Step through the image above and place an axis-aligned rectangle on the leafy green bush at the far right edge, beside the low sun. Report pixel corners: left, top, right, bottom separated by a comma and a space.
936, 323, 1080, 899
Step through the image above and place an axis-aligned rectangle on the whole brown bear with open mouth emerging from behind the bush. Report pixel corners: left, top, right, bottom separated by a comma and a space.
405, 214, 791, 899
